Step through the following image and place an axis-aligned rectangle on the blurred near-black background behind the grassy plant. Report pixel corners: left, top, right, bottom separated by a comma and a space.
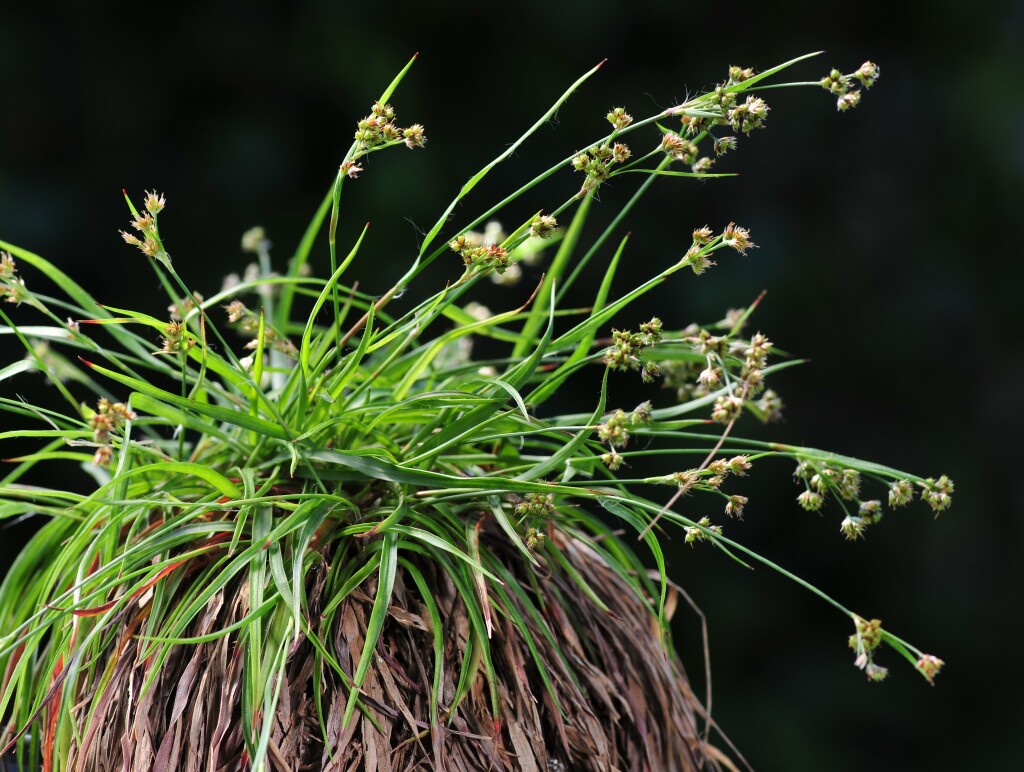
0, 0, 1024, 770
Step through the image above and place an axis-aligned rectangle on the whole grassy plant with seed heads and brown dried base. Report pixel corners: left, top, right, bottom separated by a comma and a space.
0, 51, 953, 769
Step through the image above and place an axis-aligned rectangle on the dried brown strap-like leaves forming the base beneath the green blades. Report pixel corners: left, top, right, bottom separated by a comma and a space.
66, 533, 731, 772
